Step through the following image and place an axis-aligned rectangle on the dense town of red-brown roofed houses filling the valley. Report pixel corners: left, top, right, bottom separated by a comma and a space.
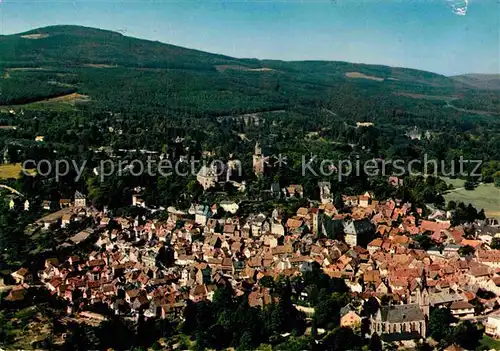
5, 184, 500, 346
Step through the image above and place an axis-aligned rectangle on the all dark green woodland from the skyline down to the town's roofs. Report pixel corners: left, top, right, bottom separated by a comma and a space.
0, 26, 500, 221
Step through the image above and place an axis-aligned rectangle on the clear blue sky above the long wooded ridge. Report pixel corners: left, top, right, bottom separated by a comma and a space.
0, 0, 500, 75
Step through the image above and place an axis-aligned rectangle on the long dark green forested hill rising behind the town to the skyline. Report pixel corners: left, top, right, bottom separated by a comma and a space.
0, 26, 498, 115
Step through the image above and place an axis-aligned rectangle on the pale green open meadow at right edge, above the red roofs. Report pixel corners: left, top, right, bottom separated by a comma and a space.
443, 178, 500, 219
